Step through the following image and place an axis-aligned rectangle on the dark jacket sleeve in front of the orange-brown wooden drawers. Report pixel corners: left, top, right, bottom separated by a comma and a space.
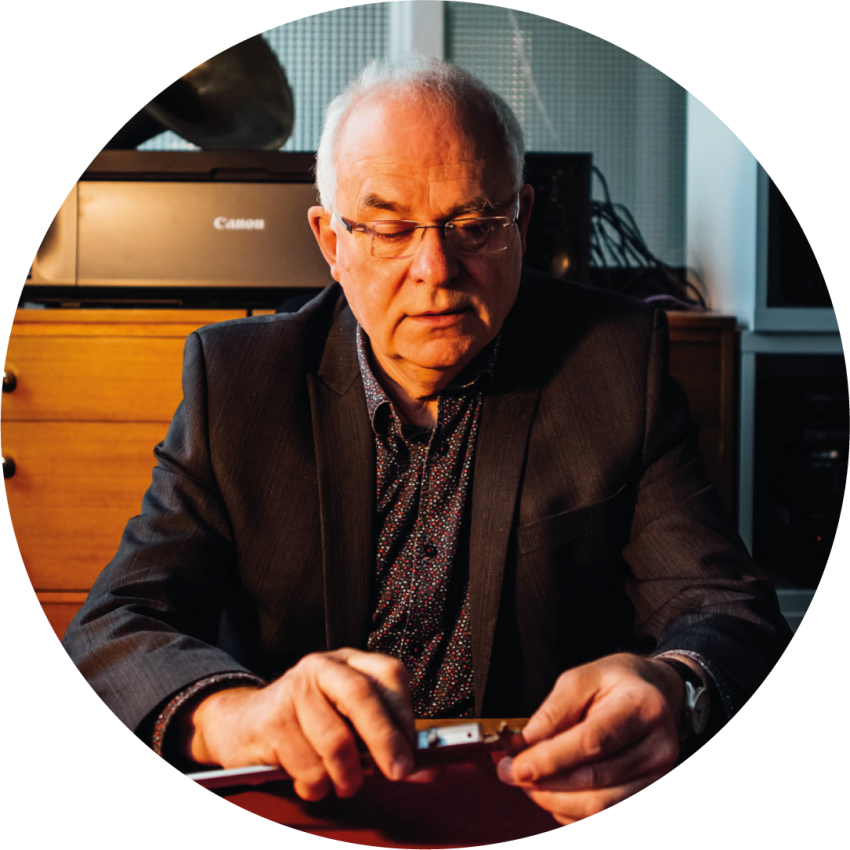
62, 334, 251, 743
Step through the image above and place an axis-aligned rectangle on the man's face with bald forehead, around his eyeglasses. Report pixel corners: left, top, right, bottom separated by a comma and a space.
310, 96, 533, 383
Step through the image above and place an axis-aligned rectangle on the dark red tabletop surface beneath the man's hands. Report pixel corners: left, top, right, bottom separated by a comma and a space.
221, 762, 559, 850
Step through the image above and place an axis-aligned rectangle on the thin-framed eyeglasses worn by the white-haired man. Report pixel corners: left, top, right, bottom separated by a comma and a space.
335, 201, 519, 260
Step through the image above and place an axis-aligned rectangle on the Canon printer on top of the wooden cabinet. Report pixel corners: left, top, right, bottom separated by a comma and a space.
26, 150, 332, 306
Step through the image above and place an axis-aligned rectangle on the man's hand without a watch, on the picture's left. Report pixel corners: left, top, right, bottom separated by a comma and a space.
187, 649, 415, 800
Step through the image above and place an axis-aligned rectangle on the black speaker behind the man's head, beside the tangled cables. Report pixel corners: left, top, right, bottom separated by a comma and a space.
524, 153, 593, 283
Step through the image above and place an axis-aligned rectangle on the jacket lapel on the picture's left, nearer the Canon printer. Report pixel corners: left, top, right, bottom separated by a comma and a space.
308, 306, 376, 649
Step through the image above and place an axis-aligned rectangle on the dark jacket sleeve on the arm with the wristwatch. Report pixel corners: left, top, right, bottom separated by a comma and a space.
623, 304, 792, 719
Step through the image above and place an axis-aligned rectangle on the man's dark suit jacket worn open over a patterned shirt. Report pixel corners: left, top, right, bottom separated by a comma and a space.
63, 273, 790, 730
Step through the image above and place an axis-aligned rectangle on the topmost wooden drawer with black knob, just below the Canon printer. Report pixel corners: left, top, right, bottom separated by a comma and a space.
0, 335, 185, 422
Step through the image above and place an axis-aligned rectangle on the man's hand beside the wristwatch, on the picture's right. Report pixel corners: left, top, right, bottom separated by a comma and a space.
499, 654, 684, 825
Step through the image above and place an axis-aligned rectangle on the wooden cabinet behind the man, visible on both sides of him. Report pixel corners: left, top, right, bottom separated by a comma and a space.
0, 309, 737, 637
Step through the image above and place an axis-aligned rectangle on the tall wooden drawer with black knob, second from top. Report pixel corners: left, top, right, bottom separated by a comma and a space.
0, 422, 168, 591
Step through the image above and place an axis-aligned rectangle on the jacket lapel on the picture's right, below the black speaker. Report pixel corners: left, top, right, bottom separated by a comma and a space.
469, 288, 545, 717
